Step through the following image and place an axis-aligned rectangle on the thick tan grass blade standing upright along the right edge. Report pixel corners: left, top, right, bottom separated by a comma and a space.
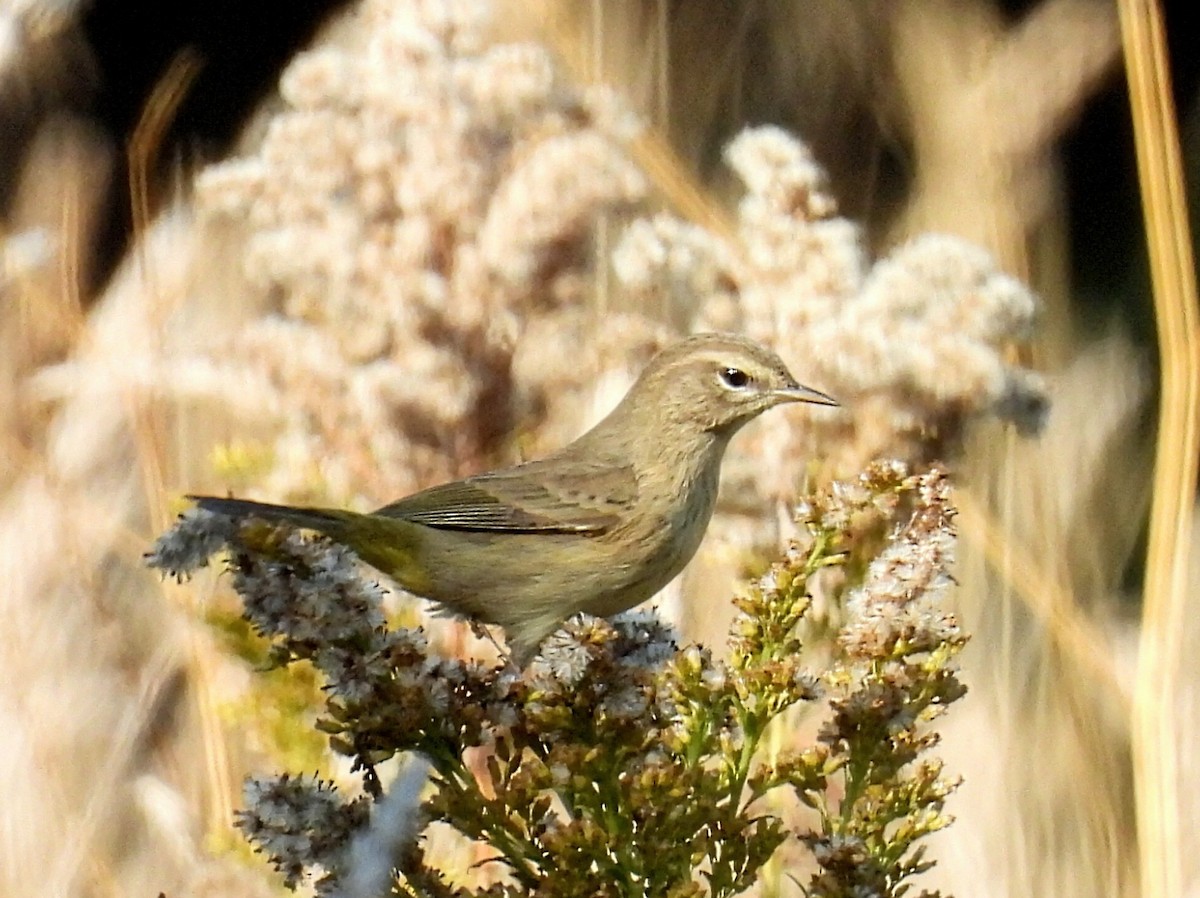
1117, 0, 1200, 898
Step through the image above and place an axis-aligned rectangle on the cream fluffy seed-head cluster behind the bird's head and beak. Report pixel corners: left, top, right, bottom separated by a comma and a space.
614, 127, 1046, 485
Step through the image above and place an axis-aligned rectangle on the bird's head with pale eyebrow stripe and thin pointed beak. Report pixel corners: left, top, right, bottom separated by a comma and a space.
628, 334, 838, 437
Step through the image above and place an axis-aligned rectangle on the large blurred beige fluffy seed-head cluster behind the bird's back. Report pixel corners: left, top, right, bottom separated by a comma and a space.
196, 0, 661, 499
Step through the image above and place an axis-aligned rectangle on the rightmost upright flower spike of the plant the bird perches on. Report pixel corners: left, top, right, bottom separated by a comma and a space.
796, 465, 967, 898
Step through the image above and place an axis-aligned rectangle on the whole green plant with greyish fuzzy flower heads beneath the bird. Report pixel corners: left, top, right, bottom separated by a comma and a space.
149, 463, 965, 898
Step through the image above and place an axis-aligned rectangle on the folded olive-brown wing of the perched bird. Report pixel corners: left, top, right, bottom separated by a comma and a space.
376, 459, 637, 533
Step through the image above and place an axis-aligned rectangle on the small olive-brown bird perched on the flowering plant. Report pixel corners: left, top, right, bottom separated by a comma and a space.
188, 334, 838, 669
